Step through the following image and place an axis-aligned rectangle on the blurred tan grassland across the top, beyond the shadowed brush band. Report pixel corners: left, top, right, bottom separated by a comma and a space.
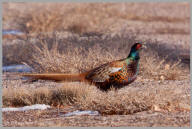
3, 2, 190, 42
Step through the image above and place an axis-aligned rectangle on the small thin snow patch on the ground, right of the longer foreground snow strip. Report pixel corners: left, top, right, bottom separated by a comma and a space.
61, 110, 99, 117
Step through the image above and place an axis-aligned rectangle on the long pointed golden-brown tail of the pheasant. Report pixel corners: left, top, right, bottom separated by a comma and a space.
21, 73, 86, 82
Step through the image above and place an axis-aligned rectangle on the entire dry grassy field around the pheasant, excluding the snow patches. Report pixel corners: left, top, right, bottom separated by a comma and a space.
2, 2, 190, 126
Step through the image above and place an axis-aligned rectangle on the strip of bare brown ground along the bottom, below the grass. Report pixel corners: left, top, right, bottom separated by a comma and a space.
3, 109, 190, 127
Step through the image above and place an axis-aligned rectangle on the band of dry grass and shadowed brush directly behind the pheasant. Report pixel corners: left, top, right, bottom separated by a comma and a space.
3, 32, 187, 80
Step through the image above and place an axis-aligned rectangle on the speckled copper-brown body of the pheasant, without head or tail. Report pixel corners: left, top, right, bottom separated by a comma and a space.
85, 59, 139, 90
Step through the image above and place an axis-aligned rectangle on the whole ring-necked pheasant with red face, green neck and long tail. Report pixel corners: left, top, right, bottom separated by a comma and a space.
22, 43, 145, 90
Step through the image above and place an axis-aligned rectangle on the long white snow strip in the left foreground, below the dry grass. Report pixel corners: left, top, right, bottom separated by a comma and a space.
2, 104, 50, 112
